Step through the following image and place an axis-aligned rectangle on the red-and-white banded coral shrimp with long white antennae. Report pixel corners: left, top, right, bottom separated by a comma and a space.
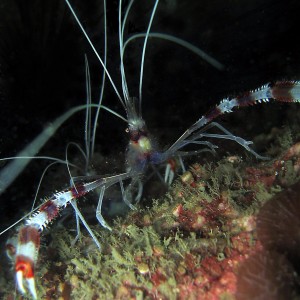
0, 0, 300, 299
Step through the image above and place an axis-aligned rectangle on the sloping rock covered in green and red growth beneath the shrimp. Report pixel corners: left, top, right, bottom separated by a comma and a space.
1, 138, 300, 299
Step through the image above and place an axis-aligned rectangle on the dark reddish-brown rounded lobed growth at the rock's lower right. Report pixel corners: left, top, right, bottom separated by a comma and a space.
237, 182, 300, 300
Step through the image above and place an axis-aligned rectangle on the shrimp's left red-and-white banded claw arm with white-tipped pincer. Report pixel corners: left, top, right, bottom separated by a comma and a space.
6, 173, 132, 299
